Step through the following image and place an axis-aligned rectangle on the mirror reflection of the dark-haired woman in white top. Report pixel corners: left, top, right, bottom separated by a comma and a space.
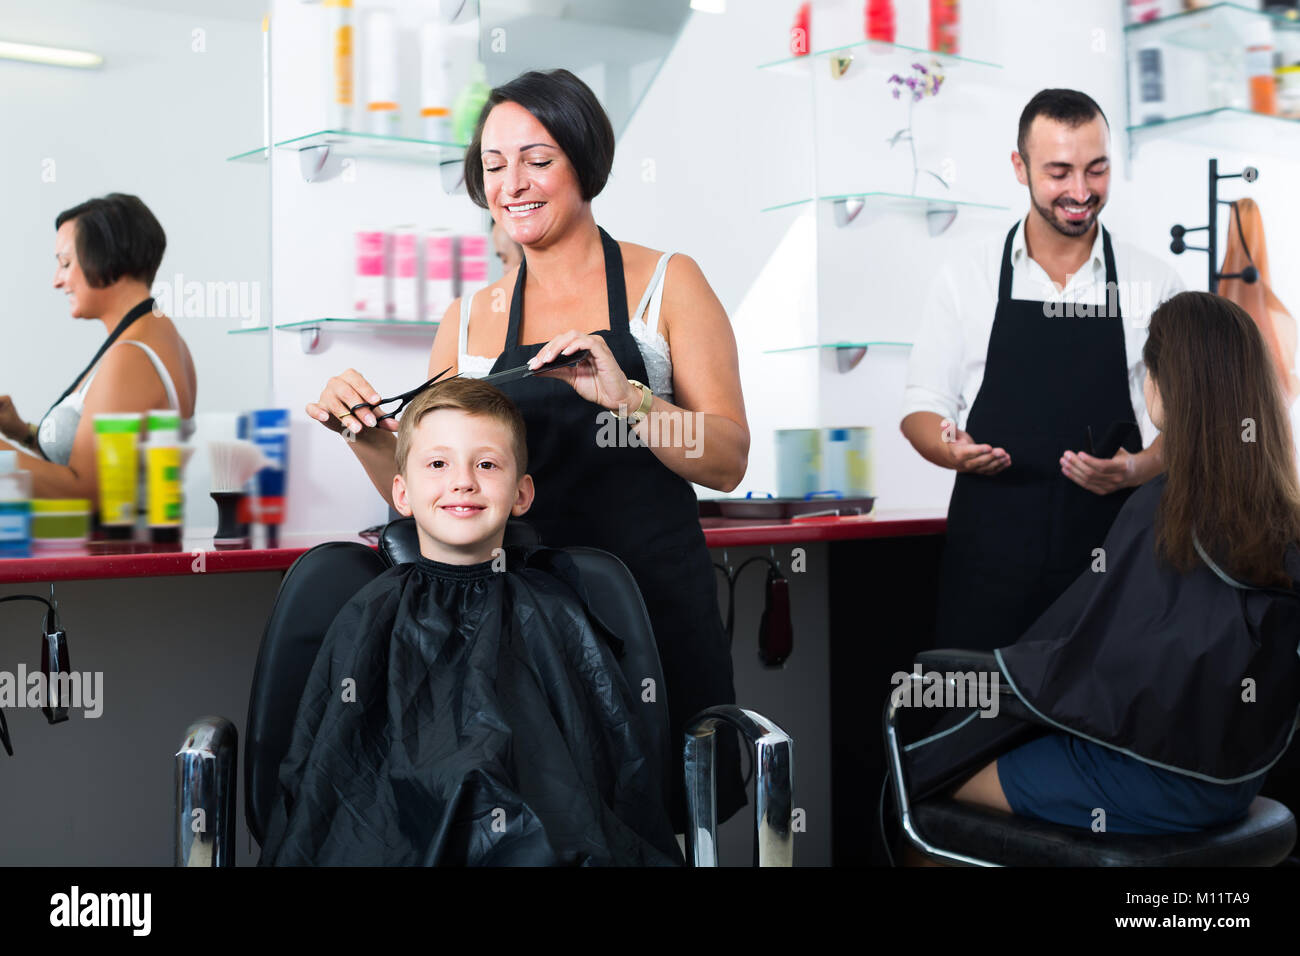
0, 193, 198, 499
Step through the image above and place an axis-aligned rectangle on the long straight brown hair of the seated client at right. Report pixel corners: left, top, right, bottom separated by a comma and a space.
1143, 293, 1300, 588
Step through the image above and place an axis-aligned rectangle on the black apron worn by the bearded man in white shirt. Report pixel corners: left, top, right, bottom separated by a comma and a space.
936, 226, 1141, 650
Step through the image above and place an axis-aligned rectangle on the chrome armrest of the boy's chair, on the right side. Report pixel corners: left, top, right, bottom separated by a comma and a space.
685, 705, 794, 866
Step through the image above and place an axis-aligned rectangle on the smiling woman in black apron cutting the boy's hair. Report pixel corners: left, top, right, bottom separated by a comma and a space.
307, 70, 749, 832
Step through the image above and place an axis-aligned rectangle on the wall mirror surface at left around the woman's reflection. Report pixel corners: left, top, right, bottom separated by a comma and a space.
0, 0, 272, 533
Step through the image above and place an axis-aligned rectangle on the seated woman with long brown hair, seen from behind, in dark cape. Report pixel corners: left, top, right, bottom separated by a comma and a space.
918, 293, 1300, 834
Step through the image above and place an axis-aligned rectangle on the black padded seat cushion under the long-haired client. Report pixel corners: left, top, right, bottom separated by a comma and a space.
913, 797, 1296, 866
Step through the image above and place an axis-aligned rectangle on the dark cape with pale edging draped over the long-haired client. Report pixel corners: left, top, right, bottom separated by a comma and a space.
905, 475, 1300, 800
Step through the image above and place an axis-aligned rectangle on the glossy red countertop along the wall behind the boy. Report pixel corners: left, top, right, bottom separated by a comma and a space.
0, 510, 946, 584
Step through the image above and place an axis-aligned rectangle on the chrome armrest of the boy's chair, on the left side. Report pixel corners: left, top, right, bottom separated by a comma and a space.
173, 717, 239, 866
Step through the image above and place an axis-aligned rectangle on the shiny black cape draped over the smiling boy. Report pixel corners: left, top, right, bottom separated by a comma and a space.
254, 548, 683, 866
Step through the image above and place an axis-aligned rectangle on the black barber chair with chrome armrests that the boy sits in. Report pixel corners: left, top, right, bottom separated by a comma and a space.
174, 518, 793, 866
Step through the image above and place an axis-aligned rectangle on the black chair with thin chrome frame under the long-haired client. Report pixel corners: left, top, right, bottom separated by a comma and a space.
884, 650, 1296, 866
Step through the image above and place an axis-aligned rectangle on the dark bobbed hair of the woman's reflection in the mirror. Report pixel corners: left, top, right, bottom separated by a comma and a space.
55, 193, 166, 289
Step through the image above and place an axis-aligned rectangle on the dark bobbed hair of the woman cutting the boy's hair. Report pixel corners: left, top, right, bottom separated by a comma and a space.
465, 70, 614, 209
